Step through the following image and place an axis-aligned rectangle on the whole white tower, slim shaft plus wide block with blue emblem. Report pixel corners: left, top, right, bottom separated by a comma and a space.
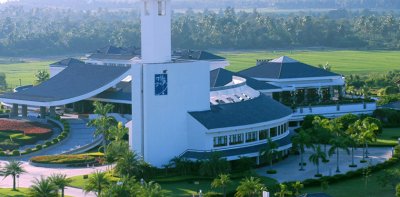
129, 0, 210, 167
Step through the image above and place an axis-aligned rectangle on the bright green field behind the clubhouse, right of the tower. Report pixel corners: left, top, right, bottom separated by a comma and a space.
217, 50, 400, 75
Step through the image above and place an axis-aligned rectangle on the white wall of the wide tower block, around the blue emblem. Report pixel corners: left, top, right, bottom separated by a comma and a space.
131, 62, 210, 167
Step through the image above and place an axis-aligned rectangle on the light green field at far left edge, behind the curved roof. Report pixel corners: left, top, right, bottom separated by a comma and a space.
0, 61, 53, 88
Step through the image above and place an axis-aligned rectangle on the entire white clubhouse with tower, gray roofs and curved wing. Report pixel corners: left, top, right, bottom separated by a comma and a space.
0, 0, 376, 167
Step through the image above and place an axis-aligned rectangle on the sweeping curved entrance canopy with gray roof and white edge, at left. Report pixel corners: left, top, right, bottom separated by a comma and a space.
0, 63, 130, 107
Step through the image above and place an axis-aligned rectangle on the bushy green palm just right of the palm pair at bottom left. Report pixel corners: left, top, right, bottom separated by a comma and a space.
83, 171, 110, 196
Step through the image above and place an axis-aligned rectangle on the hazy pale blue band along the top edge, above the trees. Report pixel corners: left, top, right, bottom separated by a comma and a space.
0, 0, 400, 9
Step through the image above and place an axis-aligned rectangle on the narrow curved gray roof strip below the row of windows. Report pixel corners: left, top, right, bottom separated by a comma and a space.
181, 132, 295, 160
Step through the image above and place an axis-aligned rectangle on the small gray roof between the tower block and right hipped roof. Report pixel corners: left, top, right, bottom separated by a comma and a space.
210, 68, 280, 90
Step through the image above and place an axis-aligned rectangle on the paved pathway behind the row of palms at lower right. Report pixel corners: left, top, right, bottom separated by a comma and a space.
256, 147, 392, 182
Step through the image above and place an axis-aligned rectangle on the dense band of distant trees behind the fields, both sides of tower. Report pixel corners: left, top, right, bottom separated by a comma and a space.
0, 7, 400, 56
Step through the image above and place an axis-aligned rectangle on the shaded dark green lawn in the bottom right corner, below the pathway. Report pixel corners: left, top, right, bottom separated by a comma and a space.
303, 164, 400, 197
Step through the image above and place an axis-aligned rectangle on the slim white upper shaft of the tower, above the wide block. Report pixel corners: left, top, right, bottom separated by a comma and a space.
141, 0, 171, 63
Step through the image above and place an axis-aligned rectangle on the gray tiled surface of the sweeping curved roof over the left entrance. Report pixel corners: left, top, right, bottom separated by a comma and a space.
0, 64, 130, 102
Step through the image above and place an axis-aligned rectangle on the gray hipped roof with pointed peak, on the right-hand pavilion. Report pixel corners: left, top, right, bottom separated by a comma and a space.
239, 57, 340, 79
